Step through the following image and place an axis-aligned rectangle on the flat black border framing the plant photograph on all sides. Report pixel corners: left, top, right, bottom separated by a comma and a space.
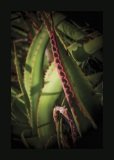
0, 0, 114, 160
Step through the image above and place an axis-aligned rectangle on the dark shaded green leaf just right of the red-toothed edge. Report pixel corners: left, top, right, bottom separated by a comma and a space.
57, 32, 99, 132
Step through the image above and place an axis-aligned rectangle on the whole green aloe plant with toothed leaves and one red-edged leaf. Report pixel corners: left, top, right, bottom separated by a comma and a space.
11, 12, 103, 148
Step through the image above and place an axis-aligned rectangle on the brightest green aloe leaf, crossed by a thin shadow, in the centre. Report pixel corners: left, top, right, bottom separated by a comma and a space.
37, 63, 62, 145
